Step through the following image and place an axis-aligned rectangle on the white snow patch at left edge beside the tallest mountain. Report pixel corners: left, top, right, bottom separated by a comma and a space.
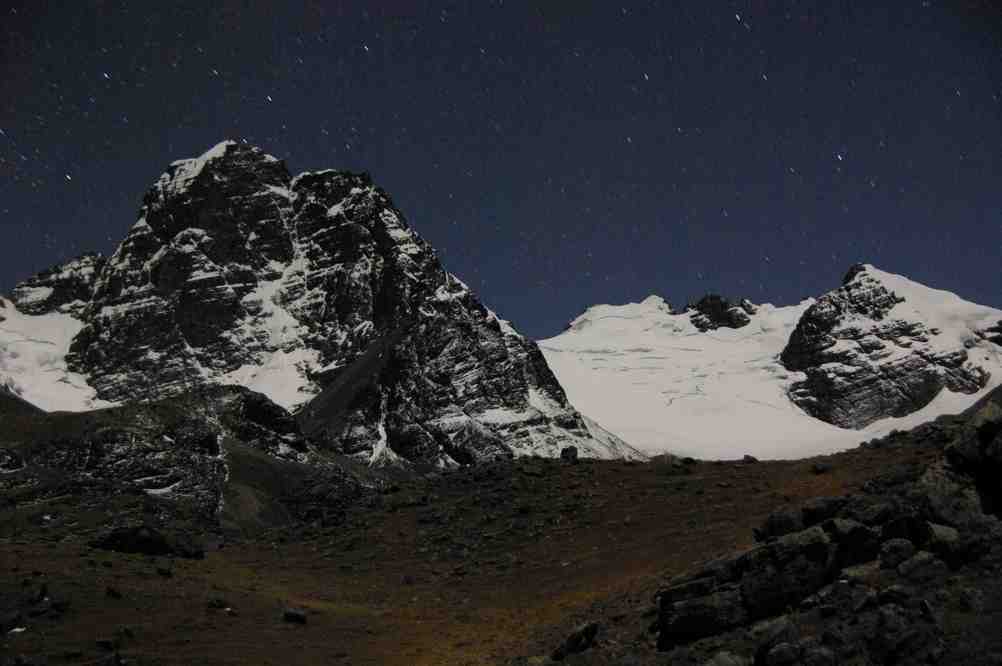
0, 297, 110, 412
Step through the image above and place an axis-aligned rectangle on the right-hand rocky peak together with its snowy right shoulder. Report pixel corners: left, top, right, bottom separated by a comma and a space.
781, 264, 997, 428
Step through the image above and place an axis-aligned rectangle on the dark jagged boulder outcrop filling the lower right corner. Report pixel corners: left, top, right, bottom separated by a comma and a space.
656, 391, 1002, 666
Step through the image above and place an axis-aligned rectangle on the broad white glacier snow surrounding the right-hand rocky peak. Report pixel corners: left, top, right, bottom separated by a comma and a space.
539, 268, 1002, 459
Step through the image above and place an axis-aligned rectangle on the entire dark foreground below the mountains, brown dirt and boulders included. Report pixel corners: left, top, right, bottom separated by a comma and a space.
0, 384, 1002, 666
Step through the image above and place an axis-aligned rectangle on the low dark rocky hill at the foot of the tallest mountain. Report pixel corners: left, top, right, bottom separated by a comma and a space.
0, 387, 370, 536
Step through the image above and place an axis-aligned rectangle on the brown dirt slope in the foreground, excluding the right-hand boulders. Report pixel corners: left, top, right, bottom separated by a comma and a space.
0, 438, 937, 666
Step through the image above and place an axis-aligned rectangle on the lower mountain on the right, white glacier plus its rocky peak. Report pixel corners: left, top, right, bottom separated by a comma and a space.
540, 264, 1002, 459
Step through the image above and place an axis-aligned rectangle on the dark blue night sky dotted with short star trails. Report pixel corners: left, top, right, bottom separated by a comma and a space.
0, 0, 1002, 338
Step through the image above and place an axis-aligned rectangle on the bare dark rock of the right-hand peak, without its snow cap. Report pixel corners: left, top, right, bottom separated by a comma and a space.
781, 264, 992, 428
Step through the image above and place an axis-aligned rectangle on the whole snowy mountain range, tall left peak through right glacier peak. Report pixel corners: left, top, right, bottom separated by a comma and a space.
0, 141, 1002, 468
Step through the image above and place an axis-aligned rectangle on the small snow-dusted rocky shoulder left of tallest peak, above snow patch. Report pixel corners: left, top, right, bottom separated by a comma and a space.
11, 253, 106, 314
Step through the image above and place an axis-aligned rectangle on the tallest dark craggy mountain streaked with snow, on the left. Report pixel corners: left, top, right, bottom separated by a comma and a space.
0, 141, 642, 467
